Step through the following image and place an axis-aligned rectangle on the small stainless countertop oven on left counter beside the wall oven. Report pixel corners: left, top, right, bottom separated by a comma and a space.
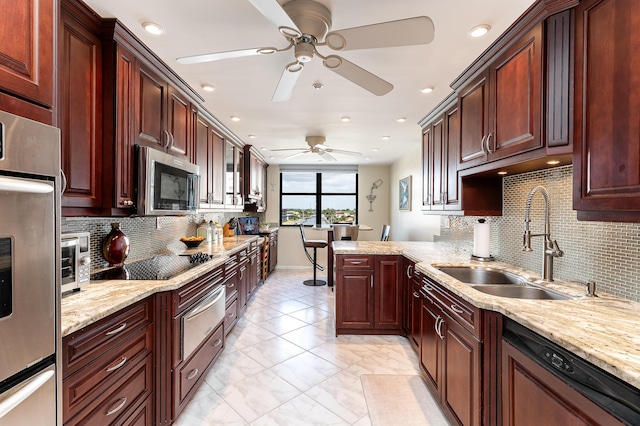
60, 232, 91, 293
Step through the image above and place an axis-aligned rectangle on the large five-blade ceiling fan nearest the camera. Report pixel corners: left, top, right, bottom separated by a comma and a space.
177, 0, 434, 102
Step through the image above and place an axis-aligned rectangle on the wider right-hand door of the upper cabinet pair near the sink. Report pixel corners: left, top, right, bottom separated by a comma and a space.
485, 24, 543, 161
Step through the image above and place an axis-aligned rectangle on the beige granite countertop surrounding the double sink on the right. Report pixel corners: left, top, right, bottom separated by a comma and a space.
333, 241, 640, 388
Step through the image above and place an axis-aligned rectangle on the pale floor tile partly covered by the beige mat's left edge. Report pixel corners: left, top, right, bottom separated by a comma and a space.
305, 371, 368, 424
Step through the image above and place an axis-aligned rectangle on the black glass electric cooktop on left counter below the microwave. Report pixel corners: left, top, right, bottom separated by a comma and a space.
90, 253, 213, 280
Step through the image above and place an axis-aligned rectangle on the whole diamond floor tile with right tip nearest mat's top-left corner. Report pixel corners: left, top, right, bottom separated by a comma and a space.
271, 352, 341, 391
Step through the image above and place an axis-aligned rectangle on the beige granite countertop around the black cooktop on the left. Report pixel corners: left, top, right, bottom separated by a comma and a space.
61, 235, 259, 336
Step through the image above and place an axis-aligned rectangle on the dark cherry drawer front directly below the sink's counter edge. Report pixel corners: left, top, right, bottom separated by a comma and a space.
422, 276, 482, 338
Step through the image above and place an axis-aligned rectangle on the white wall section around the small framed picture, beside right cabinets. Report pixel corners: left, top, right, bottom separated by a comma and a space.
390, 144, 440, 241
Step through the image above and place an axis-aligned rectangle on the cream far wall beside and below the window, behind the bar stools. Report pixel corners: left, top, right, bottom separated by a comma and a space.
265, 165, 397, 266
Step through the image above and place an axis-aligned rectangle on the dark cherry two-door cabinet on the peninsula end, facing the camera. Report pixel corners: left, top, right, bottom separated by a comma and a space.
335, 255, 403, 334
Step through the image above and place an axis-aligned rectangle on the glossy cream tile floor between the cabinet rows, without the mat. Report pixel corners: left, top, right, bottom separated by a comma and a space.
174, 269, 448, 426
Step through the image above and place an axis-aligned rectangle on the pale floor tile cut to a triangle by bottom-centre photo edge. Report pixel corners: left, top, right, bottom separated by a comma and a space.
251, 395, 349, 426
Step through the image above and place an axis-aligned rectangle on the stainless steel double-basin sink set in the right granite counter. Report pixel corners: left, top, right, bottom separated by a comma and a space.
436, 266, 572, 300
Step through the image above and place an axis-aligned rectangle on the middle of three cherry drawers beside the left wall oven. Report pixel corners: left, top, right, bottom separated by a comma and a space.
62, 327, 153, 418
